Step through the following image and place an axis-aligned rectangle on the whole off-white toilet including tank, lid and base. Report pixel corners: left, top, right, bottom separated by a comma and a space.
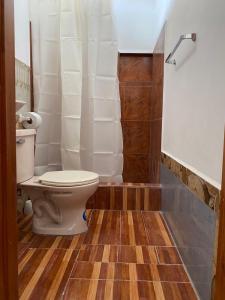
16, 129, 99, 235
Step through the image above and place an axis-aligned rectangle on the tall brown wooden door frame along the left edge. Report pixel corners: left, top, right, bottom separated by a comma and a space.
0, 0, 18, 300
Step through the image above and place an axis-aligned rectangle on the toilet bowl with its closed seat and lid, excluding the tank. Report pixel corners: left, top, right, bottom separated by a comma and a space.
21, 171, 99, 235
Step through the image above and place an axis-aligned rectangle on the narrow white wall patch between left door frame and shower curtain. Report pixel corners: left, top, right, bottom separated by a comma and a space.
14, 0, 30, 65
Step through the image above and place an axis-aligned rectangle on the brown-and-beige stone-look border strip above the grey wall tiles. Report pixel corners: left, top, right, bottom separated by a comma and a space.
161, 153, 220, 212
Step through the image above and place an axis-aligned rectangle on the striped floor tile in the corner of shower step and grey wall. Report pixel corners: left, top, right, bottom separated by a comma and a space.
142, 212, 173, 246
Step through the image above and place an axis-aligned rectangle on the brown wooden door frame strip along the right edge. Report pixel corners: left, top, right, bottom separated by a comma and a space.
215, 135, 225, 300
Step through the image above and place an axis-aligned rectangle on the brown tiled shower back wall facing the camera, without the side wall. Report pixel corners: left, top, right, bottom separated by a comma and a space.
119, 54, 152, 182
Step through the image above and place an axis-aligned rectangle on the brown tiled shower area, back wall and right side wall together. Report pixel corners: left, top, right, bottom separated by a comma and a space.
119, 45, 164, 183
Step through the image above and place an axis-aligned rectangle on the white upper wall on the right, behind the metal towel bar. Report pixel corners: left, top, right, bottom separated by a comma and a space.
162, 0, 225, 187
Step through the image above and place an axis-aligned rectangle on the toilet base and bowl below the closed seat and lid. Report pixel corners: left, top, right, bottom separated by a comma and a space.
22, 179, 98, 236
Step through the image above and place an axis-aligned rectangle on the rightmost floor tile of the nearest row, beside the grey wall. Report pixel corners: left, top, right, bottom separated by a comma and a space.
162, 282, 197, 300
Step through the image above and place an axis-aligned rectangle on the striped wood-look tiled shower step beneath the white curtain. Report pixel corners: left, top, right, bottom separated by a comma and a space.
87, 183, 161, 211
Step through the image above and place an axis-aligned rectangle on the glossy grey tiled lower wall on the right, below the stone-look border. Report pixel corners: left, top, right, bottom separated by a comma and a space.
161, 165, 216, 300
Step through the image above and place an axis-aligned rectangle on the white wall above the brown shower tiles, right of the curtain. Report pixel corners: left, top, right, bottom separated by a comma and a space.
113, 0, 173, 53
